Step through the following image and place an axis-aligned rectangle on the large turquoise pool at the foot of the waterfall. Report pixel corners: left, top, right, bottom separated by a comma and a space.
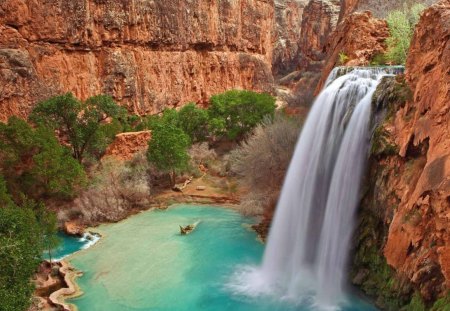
69, 205, 374, 311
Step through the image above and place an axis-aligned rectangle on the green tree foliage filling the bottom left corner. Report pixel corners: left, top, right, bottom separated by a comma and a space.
0, 175, 56, 311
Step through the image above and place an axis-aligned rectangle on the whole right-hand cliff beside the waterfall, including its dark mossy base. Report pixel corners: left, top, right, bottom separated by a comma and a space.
353, 0, 450, 310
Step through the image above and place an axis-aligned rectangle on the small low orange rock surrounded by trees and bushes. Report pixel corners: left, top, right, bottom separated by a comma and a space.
104, 131, 151, 160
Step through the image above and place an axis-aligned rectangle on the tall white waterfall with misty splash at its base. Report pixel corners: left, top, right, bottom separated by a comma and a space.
231, 67, 398, 310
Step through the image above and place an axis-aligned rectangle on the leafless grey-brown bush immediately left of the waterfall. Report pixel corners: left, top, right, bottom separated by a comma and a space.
230, 115, 299, 214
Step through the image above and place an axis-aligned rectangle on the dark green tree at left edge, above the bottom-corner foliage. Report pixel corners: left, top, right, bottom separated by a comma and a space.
0, 117, 86, 198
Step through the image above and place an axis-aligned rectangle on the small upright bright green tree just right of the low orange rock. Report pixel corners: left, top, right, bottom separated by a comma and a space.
147, 123, 190, 187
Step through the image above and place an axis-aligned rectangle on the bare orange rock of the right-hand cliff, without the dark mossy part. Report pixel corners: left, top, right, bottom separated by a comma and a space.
384, 0, 450, 299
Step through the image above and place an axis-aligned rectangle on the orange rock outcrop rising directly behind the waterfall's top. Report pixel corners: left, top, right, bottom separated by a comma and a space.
316, 11, 389, 94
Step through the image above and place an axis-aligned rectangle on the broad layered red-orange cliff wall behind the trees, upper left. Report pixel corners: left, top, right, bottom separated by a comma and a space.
0, 0, 274, 120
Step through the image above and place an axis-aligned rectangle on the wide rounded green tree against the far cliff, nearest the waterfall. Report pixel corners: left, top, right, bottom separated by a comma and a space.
208, 90, 275, 139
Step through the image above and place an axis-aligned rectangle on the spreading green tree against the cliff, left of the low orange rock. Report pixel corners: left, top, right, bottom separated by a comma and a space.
30, 93, 126, 163
